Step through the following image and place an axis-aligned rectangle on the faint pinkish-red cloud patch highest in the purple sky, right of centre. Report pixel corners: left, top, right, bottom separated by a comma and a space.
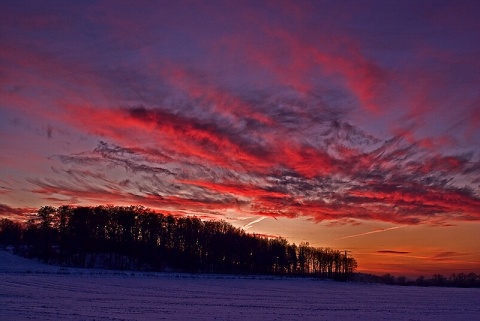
228, 28, 387, 112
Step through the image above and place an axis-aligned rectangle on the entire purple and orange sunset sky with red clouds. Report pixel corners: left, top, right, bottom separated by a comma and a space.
0, 0, 480, 276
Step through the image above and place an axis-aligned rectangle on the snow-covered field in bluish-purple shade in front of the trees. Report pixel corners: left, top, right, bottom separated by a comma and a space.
0, 251, 480, 321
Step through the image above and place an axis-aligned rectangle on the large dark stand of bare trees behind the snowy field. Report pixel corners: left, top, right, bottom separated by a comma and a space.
0, 205, 357, 280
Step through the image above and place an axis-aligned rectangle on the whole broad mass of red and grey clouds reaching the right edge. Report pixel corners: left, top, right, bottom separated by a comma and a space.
44, 100, 480, 224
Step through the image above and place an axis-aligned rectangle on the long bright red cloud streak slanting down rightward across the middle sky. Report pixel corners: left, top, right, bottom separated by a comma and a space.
60, 102, 346, 177
